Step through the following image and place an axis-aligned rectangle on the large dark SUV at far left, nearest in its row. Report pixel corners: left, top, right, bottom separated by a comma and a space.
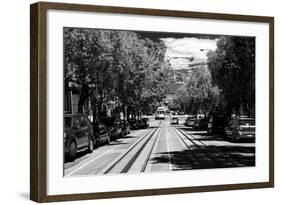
64, 114, 98, 159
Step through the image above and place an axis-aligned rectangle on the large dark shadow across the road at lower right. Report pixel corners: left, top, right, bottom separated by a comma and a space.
151, 146, 255, 170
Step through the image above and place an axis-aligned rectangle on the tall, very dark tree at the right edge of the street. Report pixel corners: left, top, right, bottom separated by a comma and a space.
208, 36, 255, 114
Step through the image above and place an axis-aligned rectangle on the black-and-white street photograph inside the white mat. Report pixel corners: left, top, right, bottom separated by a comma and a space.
62, 27, 256, 177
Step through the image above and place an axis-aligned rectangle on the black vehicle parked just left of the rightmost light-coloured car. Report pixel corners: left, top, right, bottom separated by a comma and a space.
207, 115, 226, 134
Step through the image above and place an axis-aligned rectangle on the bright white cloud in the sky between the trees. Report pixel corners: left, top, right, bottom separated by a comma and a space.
161, 37, 217, 69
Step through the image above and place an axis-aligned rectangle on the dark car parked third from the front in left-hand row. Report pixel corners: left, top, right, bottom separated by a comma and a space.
101, 117, 122, 140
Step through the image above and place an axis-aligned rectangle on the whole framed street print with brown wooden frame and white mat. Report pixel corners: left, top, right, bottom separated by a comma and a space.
30, 2, 274, 202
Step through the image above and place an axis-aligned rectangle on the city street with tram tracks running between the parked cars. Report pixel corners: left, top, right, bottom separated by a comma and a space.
64, 116, 255, 177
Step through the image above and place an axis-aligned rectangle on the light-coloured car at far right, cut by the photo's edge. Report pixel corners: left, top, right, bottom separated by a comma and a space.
225, 116, 256, 142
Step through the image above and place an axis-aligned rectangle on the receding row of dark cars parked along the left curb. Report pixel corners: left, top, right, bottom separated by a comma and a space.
64, 114, 149, 159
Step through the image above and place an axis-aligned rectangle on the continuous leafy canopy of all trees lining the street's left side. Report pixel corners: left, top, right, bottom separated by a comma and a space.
64, 28, 171, 120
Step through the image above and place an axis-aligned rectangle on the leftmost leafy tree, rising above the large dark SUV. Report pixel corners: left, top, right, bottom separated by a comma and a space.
64, 28, 117, 120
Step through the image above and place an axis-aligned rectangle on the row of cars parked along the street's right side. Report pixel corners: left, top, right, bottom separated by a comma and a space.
185, 115, 256, 142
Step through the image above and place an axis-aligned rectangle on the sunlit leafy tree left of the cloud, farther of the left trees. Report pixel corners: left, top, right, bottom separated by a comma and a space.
111, 32, 171, 116
